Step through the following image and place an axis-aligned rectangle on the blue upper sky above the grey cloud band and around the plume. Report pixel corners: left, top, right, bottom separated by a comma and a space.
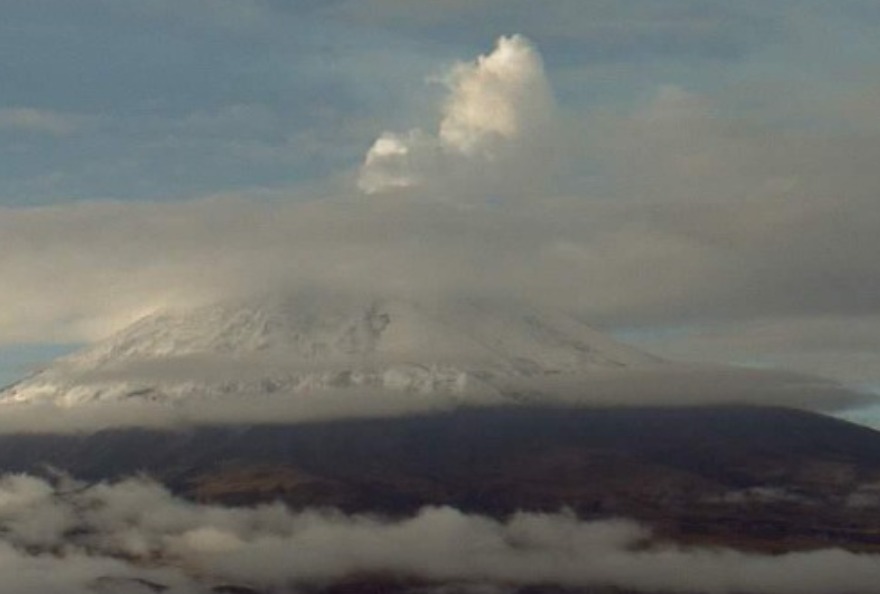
0, 0, 852, 205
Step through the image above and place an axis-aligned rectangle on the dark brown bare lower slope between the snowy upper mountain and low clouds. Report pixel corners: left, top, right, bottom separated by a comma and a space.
0, 407, 880, 550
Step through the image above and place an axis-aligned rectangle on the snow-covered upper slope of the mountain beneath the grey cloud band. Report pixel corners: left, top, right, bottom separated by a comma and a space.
0, 293, 659, 405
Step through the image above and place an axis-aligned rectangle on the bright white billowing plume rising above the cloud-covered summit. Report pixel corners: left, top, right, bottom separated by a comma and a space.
358, 35, 555, 199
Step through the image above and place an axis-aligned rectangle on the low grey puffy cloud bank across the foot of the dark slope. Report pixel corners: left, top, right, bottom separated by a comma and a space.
0, 475, 880, 594
